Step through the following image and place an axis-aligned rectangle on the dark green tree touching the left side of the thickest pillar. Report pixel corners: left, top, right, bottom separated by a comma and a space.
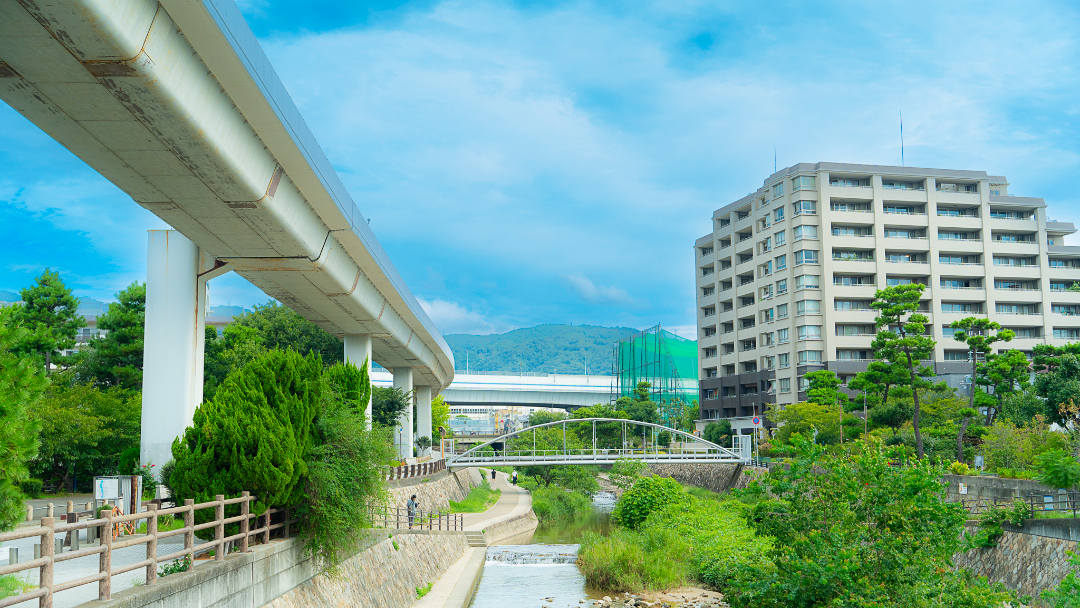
78, 282, 145, 389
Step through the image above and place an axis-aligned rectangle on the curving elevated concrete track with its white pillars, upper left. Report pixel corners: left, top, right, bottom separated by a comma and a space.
0, 0, 454, 463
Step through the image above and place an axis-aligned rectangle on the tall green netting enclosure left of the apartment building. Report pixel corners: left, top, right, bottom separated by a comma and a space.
611, 325, 698, 425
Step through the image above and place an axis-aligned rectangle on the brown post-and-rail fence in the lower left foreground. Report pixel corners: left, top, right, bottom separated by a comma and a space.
0, 491, 295, 608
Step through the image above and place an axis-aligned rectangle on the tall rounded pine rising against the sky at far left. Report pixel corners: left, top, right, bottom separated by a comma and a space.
18, 268, 86, 374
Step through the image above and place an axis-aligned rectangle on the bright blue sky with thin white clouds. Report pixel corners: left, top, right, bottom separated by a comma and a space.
0, 0, 1080, 333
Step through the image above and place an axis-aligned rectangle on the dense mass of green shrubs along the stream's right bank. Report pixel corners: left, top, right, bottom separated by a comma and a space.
579, 435, 1015, 608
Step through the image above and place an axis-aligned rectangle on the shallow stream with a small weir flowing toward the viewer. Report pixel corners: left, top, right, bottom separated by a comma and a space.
470, 492, 615, 608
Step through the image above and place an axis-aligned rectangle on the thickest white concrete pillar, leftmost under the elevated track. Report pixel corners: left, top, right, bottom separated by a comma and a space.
139, 230, 206, 472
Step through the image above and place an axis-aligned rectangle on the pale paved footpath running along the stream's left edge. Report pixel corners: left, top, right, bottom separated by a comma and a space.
413, 469, 532, 608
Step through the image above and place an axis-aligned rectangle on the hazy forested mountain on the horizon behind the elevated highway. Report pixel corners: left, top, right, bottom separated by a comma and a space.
445, 325, 639, 376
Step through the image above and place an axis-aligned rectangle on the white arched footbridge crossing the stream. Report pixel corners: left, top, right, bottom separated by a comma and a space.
446, 418, 751, 468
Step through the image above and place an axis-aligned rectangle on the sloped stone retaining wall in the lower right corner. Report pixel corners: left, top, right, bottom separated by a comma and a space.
954, 519, 1080, 597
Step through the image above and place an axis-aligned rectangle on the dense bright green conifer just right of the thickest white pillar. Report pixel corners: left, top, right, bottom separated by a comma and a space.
170, 350, 324, 517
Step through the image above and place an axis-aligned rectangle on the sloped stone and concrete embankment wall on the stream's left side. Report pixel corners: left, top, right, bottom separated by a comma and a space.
81, 469, 486, 608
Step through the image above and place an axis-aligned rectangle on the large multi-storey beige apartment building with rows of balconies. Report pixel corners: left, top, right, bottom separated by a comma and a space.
694, 163, 1080, 432
